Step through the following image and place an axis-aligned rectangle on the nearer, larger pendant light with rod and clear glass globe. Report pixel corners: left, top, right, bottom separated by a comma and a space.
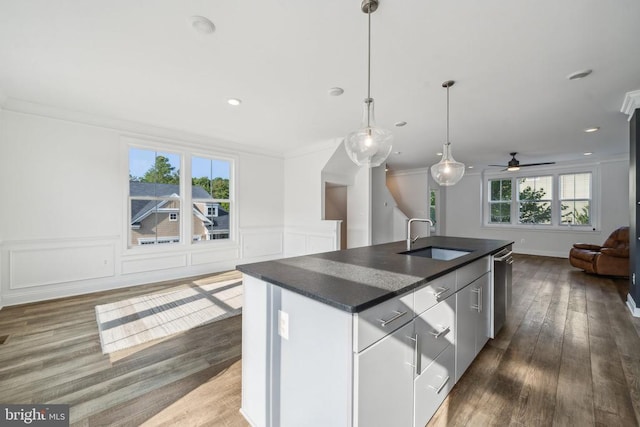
344, 0, 393, 167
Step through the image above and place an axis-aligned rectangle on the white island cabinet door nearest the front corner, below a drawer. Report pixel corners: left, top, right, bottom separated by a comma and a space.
354, 323, 415, 427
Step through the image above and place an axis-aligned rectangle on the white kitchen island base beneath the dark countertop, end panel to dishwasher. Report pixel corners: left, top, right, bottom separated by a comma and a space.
241, 257, 491, 427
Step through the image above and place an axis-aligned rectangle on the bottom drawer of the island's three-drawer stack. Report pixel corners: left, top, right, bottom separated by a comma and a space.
413, 345, 455, 427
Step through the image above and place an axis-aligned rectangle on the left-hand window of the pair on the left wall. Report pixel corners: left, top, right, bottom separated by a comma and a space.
128, 148, 182, 247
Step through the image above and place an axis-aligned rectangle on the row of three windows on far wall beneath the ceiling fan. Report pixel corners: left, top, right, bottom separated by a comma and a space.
484, 168, 596, 230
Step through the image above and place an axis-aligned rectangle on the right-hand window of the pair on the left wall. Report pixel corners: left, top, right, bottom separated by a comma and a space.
191, 157, 233, 242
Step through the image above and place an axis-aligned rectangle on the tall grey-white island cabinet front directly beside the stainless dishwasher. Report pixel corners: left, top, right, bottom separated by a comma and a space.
456, 273, 491, 382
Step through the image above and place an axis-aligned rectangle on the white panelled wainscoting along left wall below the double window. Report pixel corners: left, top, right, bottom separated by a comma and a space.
0, 227, 284, 307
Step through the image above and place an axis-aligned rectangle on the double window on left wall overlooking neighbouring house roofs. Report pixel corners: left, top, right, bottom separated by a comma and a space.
128, 147, 233, 248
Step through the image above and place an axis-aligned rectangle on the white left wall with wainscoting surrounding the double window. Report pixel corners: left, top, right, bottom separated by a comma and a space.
0, 109, 284, 305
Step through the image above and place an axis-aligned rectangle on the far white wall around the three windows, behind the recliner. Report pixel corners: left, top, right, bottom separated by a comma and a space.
445, 159, 629, 258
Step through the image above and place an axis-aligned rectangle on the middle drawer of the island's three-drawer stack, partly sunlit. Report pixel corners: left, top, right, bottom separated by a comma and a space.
415, 295, 456, 372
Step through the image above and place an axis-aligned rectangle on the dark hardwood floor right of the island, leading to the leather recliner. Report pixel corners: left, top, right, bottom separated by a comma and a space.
428, 255, 640, 427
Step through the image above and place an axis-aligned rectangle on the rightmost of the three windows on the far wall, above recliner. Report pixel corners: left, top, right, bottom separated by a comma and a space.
559, 173, 591, 225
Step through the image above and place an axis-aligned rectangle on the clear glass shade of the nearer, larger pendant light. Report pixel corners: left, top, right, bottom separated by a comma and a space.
344, 98, 393, 167
